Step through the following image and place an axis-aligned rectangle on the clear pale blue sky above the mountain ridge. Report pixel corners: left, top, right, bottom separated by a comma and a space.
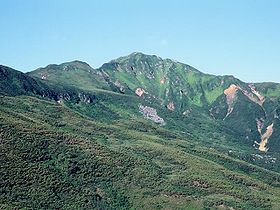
0, 0, 280, 82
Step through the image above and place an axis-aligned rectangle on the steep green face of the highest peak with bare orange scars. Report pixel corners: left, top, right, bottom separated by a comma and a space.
99, 53, 280, 154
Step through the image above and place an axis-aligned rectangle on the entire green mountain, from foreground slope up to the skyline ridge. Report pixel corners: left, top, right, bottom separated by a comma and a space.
0, 53, 280, 209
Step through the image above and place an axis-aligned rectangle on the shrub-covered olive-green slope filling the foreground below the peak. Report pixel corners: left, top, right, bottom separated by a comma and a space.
0, 96, 280, 209
